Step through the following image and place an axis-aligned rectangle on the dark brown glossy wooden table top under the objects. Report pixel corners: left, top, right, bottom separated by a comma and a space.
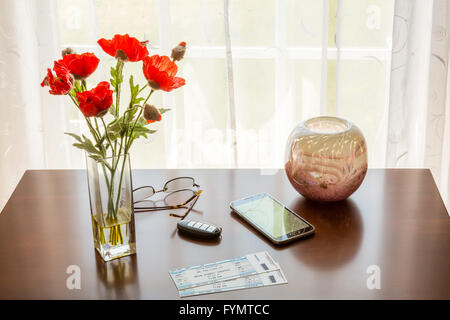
0, 169, 450, 299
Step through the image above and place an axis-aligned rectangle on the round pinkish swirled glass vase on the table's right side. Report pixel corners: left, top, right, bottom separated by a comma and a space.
285, 117, 367, 201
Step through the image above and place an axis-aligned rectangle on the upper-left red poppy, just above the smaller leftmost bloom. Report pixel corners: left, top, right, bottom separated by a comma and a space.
58, 52, 100, 80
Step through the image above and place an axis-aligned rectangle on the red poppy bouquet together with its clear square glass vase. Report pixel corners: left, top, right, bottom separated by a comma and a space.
41, 34, 186, 261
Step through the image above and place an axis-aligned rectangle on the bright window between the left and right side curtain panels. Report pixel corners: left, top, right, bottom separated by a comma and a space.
58, 0, 394, 168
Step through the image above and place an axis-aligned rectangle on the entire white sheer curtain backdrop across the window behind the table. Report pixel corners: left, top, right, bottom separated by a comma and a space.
0, 0, 450, 212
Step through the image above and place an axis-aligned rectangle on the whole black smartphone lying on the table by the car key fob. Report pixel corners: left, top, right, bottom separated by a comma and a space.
230, 193, 315, 244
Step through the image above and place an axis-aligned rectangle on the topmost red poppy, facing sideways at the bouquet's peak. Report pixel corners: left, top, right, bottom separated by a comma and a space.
97, 34, 148, 62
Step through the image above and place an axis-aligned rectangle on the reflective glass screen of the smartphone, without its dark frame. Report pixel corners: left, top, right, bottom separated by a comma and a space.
233, 194, 309, 238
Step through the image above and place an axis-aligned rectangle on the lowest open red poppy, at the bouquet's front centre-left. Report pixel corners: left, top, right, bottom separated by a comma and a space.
77, 81, 113, 117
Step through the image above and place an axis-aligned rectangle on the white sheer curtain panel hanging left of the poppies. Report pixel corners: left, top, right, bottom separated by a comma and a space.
0, 0, 70, 208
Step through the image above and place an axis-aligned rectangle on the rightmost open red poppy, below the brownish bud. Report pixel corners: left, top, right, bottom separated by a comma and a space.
142, 54, 186, 92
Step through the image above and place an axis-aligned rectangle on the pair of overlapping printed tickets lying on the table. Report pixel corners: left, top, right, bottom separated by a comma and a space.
169, 251, 287, 297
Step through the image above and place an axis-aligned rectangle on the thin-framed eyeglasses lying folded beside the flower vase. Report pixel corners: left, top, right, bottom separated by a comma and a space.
133, 177, 203, 220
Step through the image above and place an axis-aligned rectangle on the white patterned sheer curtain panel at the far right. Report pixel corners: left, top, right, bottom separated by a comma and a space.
386, 0, 450, 207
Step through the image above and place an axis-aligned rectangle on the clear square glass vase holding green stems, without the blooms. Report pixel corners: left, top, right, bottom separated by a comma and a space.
86, 154, 136, 261
